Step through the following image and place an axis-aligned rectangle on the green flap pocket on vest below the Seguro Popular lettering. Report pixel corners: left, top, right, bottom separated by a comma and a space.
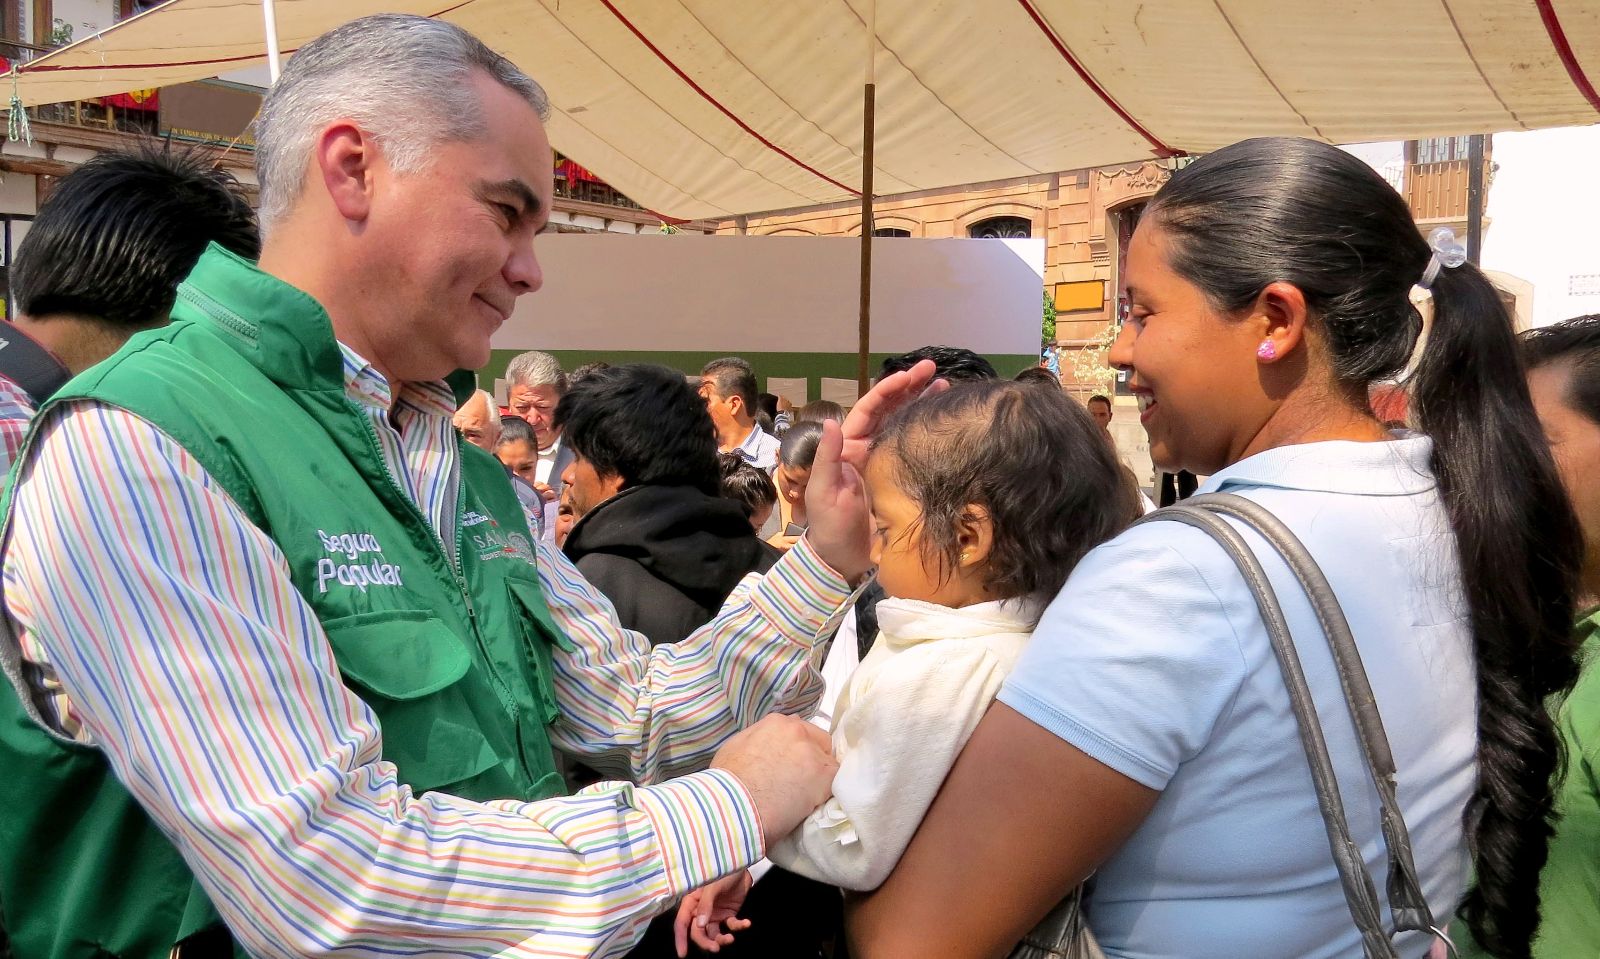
323, 610, 506, 792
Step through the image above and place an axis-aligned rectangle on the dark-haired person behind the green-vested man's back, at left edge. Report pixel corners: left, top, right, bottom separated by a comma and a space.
0, 150, 261, 467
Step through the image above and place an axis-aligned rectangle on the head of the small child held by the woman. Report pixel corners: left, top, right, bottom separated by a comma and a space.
866, 381, 1133, 607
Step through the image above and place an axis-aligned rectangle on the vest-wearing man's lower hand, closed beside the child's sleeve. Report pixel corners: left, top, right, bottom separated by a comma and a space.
710, 714, 838, 847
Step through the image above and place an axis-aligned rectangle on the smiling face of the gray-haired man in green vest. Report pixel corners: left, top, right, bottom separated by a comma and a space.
355, 75, 552, 381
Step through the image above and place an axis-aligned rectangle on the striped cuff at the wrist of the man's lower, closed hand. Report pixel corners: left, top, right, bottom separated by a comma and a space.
634, 768, 763, 898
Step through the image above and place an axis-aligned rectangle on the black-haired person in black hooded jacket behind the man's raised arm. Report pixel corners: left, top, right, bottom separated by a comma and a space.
555, 363, 774, 644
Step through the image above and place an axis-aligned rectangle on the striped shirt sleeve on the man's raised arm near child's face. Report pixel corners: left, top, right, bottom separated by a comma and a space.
538, 538, 850, 783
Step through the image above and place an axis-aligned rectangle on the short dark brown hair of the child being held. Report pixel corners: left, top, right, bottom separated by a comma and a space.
872, 381, 1133, 599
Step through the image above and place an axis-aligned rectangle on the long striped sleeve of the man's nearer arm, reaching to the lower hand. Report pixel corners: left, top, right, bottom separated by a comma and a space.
3, 403, 762, 957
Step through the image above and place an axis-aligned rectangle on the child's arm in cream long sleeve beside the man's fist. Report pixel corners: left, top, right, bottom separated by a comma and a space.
768, 640, 1006, 890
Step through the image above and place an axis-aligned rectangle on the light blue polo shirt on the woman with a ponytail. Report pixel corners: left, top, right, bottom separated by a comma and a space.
1000, 434, 1477, 959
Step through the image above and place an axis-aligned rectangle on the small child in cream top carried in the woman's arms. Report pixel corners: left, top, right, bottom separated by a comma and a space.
678, 381, 1134, 946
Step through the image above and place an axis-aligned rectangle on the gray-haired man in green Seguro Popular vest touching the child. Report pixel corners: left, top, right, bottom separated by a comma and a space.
0, 14, 908, 959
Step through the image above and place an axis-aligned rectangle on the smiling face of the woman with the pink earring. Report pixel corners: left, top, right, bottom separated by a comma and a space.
1110, 219, 1272, 474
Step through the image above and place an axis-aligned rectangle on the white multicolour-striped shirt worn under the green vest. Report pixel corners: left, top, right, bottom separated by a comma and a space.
3, 347, 848, 956
